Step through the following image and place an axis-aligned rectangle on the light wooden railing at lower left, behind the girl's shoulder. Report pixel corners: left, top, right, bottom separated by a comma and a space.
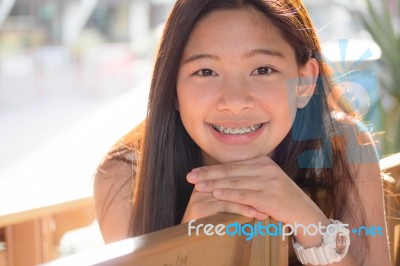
0, 197, 95, 266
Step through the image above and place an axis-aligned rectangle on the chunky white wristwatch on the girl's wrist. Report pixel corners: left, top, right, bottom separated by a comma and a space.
292, 219, 350, 265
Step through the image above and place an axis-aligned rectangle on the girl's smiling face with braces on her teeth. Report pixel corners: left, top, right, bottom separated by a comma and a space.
177, 9, 318, 165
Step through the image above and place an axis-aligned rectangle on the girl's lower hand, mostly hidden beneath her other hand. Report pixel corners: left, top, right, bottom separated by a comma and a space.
181, 189, 259, 223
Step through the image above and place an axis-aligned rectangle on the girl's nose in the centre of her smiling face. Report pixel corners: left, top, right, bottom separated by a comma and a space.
217, 79, 255, 114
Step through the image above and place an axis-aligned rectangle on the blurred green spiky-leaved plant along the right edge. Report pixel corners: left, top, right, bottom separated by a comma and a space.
352, 0, 400, 154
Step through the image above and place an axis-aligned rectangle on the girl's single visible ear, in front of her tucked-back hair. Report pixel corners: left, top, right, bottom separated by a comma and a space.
296, 58, 319, 109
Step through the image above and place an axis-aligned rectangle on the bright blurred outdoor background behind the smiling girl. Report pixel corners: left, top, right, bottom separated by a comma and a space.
0, 0, 400, 265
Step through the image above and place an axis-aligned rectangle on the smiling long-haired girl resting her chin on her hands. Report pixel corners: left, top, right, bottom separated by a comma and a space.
94, 0, 389, 265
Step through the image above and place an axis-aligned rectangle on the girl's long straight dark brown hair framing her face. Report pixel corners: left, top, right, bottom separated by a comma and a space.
126, 0, 363, 251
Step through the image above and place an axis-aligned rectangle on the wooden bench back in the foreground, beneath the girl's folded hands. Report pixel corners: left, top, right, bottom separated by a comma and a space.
46, 213, 289, 266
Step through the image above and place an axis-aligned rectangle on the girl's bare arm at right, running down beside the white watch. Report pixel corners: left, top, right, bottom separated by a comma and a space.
344, 127, 390, 266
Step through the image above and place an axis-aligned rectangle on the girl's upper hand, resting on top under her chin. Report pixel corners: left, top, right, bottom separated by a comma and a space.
187, 156, 329, 246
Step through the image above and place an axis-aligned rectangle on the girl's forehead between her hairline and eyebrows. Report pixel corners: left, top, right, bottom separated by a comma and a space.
184, 8, 293, 54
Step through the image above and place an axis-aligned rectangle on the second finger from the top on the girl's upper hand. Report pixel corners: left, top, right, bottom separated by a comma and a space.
195, 176, 266, 192
